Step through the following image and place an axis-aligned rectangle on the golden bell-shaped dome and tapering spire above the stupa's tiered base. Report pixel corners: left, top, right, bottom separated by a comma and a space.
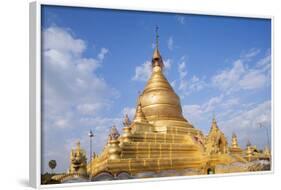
140, 48, 186, 121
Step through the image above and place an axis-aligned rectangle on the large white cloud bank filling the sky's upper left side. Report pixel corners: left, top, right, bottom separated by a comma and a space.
43, 27, 117, 116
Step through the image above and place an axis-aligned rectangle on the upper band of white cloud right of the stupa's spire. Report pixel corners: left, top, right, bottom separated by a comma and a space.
173, 48, 271, 97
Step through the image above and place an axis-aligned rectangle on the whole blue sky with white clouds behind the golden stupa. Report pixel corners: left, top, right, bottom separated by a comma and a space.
42, 6, 271, 172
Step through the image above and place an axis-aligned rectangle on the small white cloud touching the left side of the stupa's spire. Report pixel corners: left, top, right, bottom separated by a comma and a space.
133, 61, 152, 81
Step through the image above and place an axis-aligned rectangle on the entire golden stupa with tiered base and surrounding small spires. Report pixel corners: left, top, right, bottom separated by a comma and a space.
52, 28, 270, 181
